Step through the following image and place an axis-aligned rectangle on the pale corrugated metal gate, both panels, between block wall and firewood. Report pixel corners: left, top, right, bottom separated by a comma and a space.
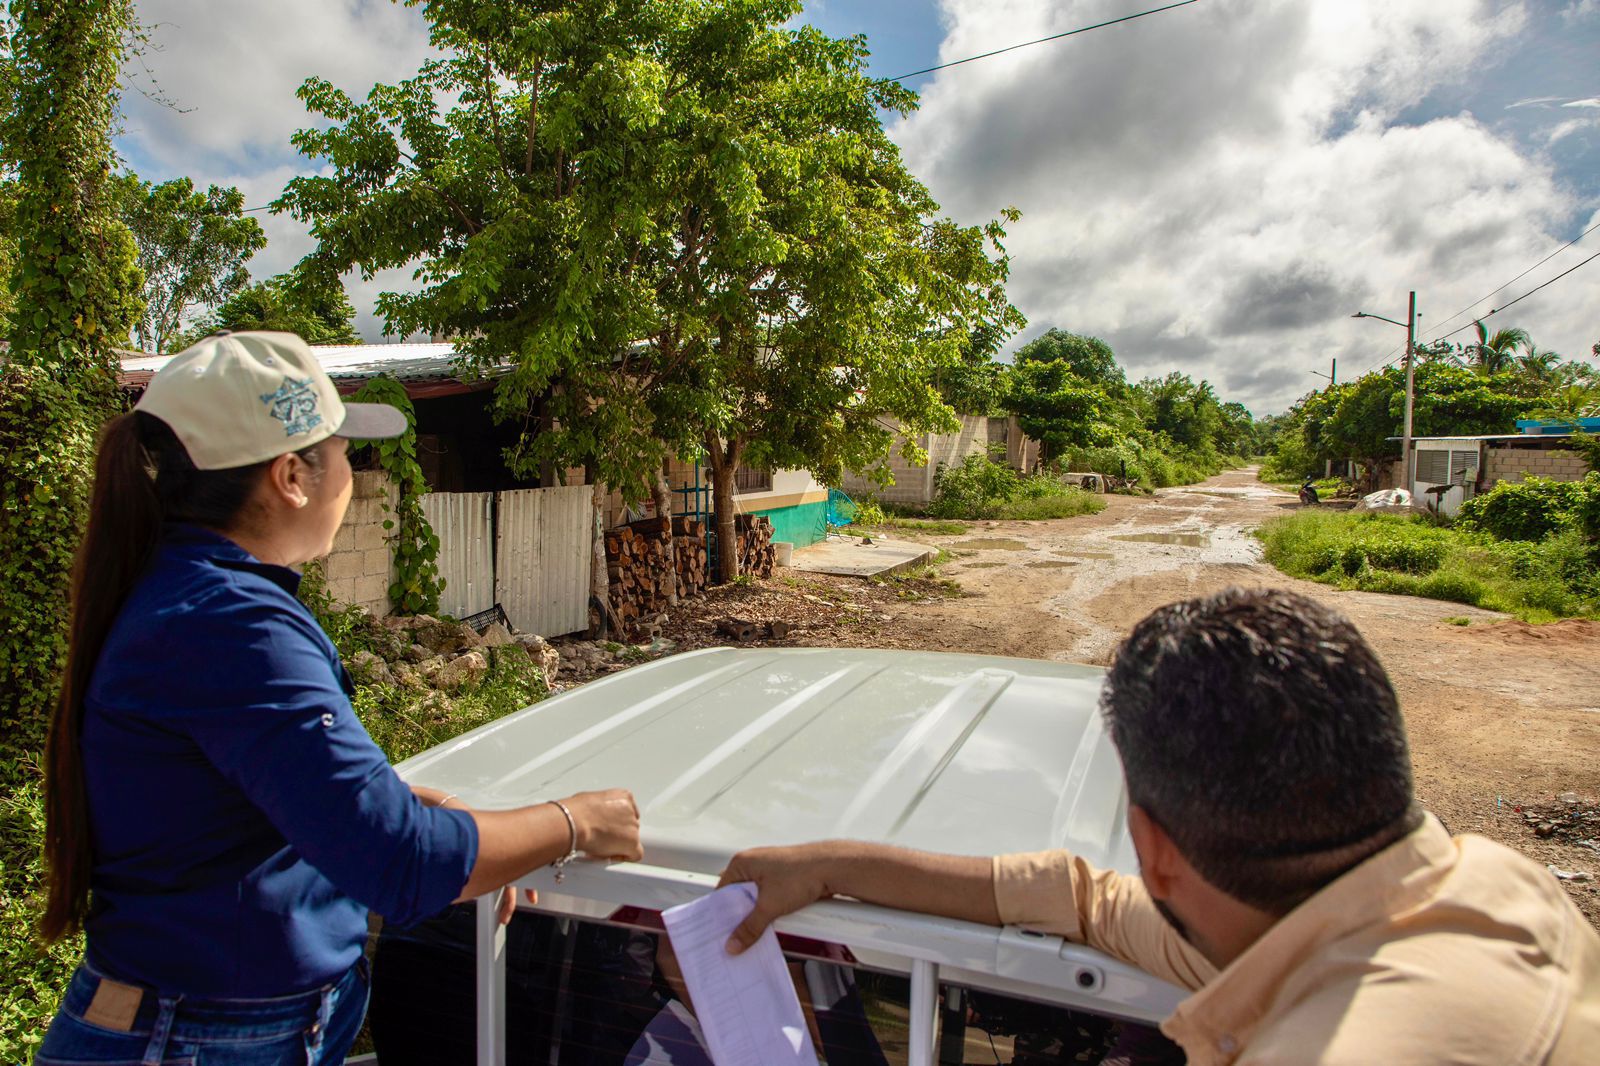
422, 485, 594, 637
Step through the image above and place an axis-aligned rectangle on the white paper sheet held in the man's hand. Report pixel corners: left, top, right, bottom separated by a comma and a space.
661, 884, 818, 1066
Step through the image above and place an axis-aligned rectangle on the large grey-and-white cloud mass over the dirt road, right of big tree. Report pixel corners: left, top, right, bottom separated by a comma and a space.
894, 0, 1600, 411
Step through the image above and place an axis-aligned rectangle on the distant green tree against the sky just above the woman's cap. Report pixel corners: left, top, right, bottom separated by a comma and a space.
117, 174, 267, 352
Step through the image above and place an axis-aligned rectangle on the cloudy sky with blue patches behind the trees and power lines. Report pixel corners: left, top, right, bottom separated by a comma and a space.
118, 0, 1600, 415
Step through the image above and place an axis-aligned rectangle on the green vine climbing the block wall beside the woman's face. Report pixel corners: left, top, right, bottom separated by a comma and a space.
350, 375, 445, 615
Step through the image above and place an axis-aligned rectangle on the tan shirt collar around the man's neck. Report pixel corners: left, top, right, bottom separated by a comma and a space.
1162, 815, 1456, 1061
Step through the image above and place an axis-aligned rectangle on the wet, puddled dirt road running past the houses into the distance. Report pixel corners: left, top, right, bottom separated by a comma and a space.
808, 471, 1600, 924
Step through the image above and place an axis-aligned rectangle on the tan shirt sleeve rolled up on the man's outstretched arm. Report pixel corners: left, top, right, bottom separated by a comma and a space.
994, 852, 1216, 989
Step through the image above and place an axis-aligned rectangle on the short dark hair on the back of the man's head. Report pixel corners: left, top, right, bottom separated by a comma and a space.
1101, 589, 1416, 914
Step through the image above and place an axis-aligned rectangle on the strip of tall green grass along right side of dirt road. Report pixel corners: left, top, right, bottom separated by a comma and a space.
1256, 511, 1600, 623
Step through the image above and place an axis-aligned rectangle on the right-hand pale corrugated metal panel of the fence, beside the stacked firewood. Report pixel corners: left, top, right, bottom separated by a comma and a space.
496, 485, 594, 637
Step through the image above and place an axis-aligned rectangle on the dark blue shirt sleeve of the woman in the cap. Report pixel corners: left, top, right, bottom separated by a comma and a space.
189, 603, 478, 925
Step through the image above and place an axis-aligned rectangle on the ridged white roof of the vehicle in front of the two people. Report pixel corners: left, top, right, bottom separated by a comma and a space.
402, 648, 1136, 874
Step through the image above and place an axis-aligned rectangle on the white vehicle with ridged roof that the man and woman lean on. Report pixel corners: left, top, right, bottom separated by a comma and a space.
379, 648, 1182, 1066
